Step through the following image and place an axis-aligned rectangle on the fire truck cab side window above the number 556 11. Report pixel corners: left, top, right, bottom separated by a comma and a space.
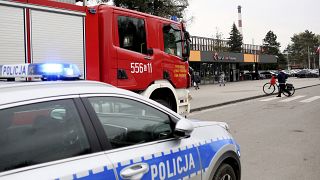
118, 16, 147, 54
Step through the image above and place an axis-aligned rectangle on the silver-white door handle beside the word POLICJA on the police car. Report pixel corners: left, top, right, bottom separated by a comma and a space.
120, 163, 149, 179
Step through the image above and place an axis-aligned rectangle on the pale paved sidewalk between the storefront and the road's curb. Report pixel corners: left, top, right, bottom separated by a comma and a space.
189, 77, 320, 112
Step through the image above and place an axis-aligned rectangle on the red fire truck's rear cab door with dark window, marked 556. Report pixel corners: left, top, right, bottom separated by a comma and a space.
114, 13, 153, 90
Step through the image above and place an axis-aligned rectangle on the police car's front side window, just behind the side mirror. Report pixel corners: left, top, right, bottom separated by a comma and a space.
89, 97, 173, 148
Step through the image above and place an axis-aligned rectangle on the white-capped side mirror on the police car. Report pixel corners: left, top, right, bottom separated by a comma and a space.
173, 119, 193, 138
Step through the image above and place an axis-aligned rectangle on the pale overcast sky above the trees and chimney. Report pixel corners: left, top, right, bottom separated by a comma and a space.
186, 0, 320, 50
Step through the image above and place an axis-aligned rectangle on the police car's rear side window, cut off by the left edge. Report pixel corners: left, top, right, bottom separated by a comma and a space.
0, 99, 90, 172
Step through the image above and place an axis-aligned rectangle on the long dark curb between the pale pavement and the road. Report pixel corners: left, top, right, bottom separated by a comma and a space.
190, 84, 320, 113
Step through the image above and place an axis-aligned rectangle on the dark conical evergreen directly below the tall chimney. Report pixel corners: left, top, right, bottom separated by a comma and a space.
227, 23, 242, 52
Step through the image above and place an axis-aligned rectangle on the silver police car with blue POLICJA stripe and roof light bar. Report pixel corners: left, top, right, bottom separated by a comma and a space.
0, 64, 241, 180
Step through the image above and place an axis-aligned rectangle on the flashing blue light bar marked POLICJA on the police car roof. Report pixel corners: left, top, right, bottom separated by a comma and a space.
0, 63, 81, 80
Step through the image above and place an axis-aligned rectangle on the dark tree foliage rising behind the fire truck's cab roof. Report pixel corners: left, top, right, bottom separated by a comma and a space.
113, 0, 189, 18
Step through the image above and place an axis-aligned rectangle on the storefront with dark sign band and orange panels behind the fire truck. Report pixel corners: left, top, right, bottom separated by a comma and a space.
189, 51, 277, 84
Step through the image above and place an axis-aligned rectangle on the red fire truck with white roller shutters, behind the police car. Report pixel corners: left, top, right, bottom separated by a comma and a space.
0, 0, 190, 114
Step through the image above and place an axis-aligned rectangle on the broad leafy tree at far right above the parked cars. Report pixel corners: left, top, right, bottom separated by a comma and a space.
285, 30, 320, 68
